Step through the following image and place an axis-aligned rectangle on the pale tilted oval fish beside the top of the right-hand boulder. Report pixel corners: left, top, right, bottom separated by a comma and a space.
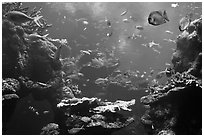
179, 13, 193, 31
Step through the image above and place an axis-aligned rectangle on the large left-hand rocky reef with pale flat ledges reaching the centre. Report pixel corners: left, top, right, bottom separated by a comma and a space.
2, 2, 134, 135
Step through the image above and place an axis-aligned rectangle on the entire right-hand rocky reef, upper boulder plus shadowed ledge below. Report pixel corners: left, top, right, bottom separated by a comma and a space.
141, 18, 202, 135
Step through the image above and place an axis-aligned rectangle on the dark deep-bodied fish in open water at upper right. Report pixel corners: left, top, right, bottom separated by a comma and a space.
148, 10, 169, 26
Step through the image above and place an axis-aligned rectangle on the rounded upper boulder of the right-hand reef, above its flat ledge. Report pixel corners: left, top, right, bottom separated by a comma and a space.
172, 18, 202, 76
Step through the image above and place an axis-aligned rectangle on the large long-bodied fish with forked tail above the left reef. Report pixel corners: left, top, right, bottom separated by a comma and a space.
5, 11, 43, 27
